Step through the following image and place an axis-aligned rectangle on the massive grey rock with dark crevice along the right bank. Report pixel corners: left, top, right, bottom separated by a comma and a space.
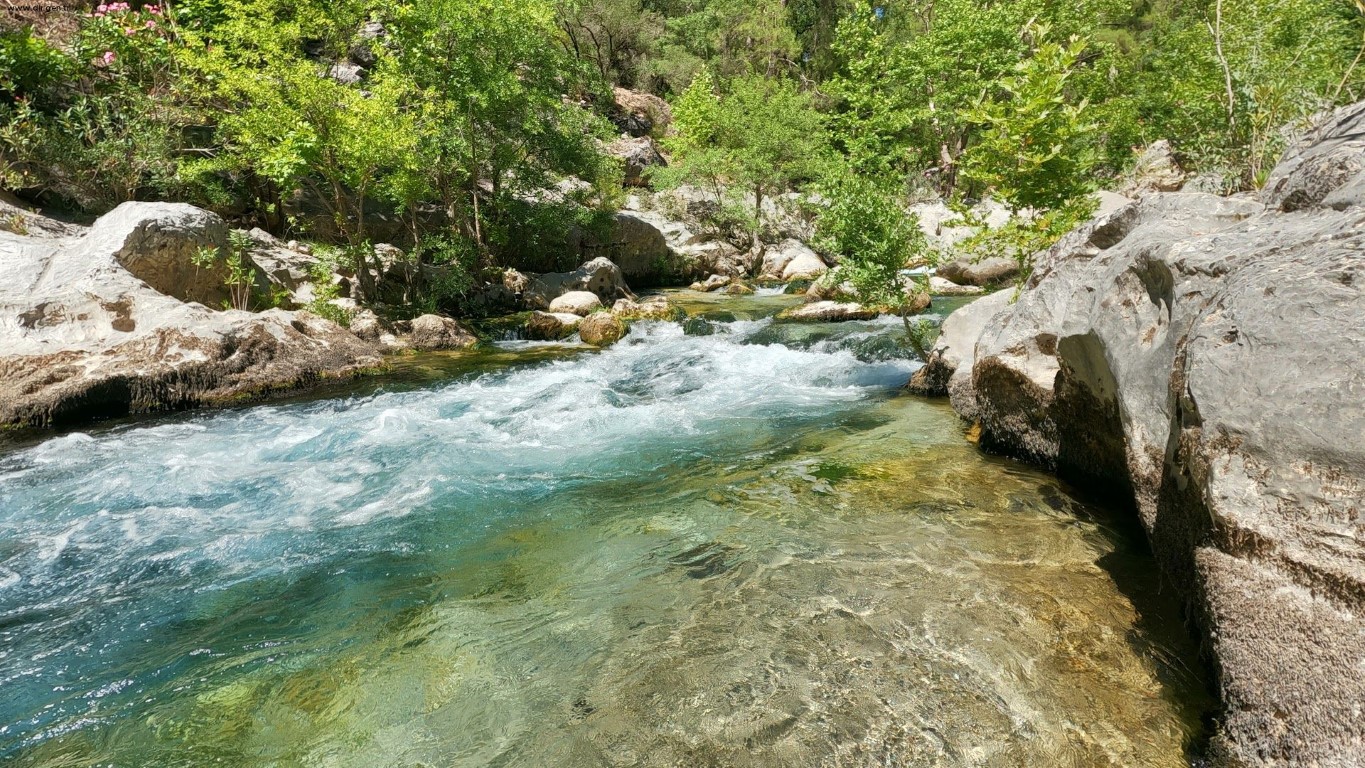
916, 105, 1365, 767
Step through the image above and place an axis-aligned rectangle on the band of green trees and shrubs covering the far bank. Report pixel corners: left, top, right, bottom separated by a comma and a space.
8, 0, 1365, 311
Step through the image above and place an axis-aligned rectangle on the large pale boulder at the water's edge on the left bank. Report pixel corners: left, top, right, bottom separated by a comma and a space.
0, 203, 381, 426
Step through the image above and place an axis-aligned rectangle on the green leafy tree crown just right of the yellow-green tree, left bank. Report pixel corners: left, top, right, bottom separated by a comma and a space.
394, 0, 618, 248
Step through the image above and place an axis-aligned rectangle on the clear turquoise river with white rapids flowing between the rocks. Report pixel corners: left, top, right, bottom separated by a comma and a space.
0, 293, 1211, 768
